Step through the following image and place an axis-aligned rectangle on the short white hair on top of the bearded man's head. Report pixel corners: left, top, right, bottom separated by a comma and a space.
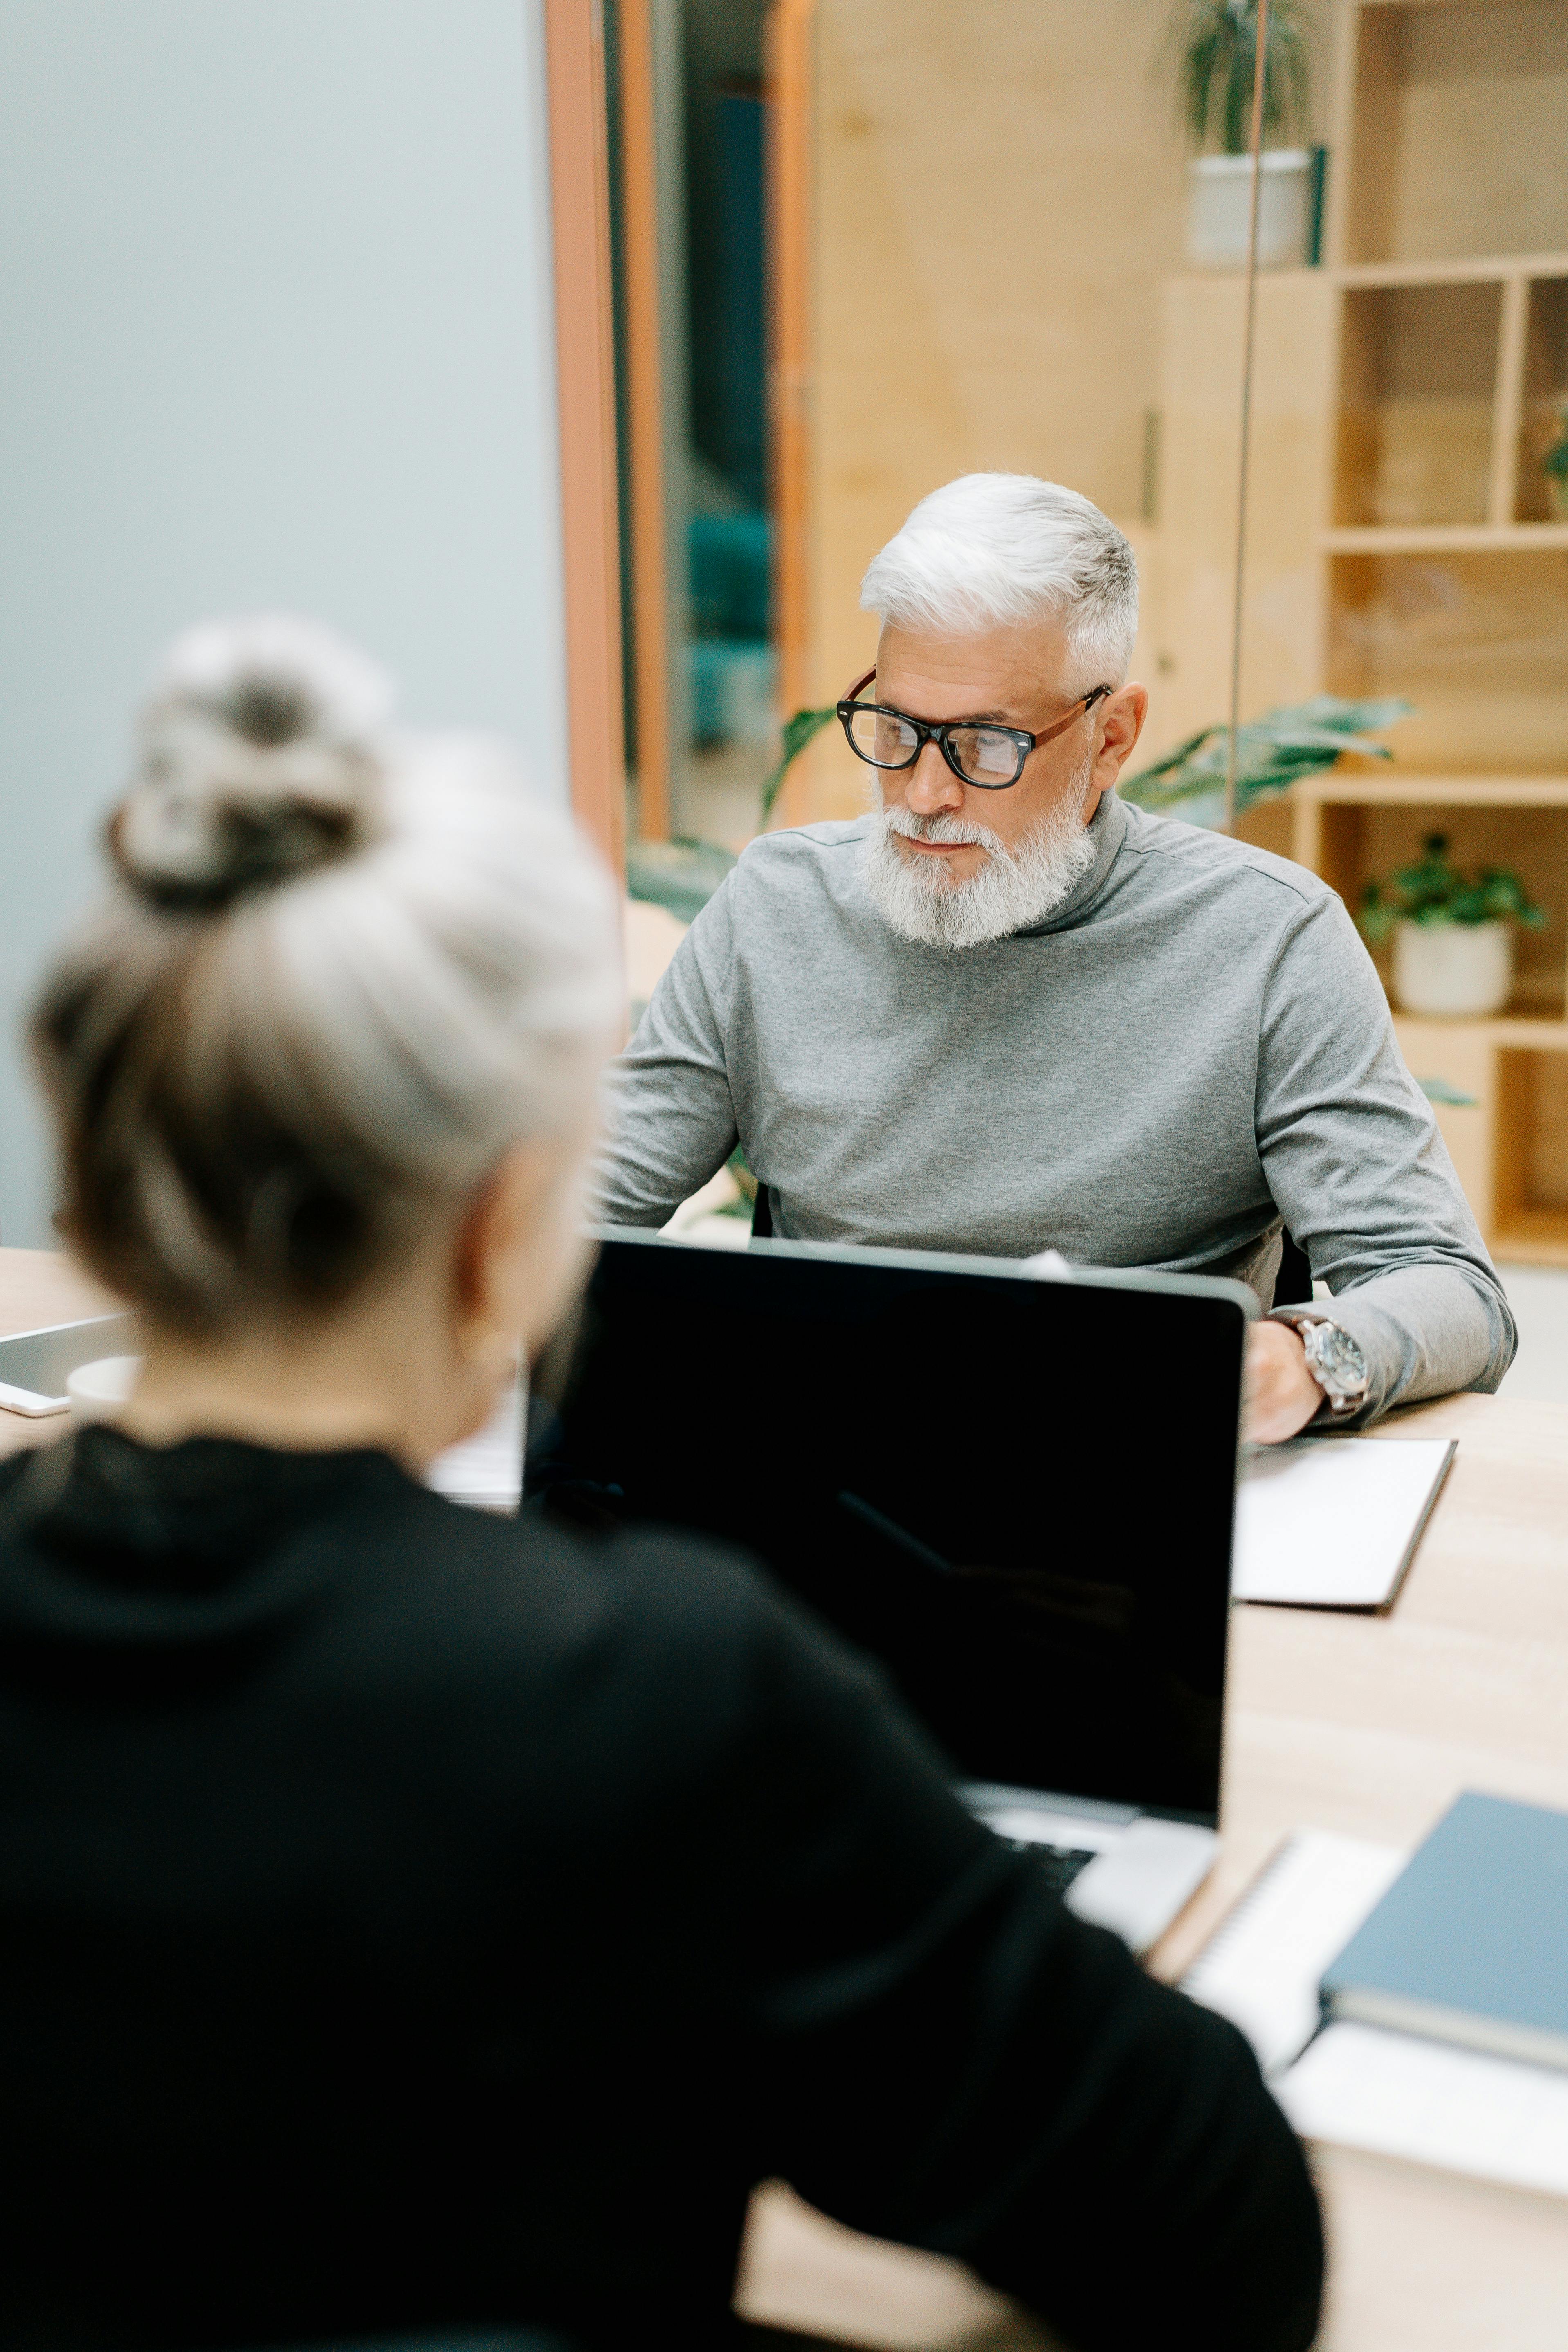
860, 473, 1138, 692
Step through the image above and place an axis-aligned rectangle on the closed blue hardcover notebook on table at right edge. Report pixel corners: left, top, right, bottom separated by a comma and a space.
1323, 1790, 1568, 2070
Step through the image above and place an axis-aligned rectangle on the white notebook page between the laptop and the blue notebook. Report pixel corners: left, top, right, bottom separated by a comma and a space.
1182, 1830, 1408, 2074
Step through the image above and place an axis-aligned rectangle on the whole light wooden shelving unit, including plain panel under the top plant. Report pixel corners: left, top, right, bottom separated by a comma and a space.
1159, 0, 1568, 1265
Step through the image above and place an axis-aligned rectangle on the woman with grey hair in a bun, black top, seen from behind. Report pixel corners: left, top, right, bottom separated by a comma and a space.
0, 621, 1321, 2352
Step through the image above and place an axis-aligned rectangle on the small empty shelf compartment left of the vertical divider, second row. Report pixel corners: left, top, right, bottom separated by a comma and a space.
1335, 282, 1502, 529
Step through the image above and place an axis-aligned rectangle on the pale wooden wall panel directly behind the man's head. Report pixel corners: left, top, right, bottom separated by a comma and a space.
809, 0, 1182, 814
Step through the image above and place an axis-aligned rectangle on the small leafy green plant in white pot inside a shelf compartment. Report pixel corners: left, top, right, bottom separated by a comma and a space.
1359, 833, 1547, 1014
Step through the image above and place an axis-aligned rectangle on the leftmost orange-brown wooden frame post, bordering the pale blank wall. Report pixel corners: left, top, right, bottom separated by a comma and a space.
546, 0, 625, 877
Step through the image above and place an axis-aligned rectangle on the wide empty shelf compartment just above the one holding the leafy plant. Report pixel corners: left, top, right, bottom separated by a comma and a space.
1328, 548, 1568, 774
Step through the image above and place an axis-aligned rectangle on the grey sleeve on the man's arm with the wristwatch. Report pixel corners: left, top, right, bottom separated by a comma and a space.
1255, 899, 1516, 1425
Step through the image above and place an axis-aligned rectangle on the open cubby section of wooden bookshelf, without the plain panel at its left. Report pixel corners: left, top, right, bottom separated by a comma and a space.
1293, 0, 1568, 1265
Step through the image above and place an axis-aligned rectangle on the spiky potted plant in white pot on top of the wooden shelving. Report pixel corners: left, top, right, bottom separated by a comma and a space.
1171, 0, 1321, 268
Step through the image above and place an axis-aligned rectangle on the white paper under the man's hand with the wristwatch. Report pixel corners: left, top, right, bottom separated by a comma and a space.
1229, 1437, 1453, 1609
